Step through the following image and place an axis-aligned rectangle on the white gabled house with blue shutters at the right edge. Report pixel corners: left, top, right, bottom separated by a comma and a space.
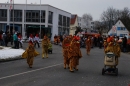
108, 20, 129, 37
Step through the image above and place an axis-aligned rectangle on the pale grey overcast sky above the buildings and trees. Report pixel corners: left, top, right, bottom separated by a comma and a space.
0, 0, 130, 20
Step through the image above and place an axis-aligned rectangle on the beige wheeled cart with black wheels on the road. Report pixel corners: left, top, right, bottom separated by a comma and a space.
102, 52, 118, 76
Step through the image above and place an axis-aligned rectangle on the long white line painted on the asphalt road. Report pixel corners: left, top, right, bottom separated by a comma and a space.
0, 63, 63, 80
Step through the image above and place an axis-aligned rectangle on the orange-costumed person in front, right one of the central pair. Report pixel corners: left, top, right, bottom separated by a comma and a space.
68, 36, 82, 72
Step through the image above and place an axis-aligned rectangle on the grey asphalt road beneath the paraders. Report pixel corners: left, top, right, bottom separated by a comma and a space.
0, 44, 130, 86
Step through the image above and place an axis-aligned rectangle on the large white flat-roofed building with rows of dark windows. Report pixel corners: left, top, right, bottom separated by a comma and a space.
0, 3, 71, 40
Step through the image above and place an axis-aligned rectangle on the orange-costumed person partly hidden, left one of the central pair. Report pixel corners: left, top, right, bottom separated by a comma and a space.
62, 36, 70, 69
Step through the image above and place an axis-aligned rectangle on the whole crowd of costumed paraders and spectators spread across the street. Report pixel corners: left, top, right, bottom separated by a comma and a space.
0, 32, 130, 72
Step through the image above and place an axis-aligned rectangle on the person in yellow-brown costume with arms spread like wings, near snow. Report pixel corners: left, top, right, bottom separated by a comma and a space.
22, 41, 39, 68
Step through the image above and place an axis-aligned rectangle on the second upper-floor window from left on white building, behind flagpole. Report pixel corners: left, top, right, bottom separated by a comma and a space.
10, 10, 22, 22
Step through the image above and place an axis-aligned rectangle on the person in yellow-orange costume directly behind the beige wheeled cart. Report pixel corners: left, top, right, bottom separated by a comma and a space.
105, 40, 121, 66
